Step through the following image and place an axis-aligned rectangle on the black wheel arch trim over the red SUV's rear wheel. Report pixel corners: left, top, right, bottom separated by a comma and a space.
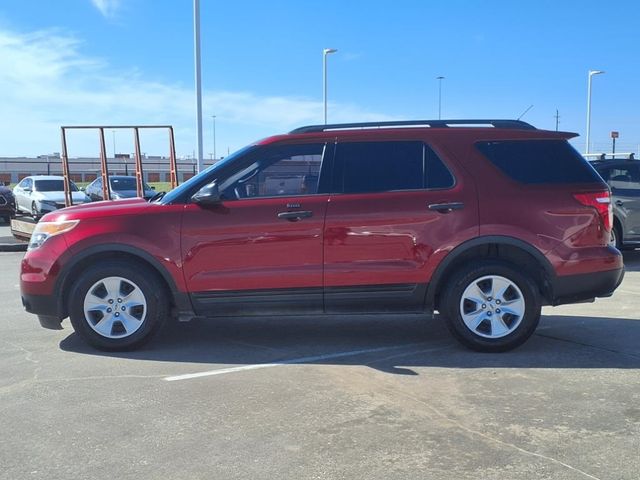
425, 235, 555, 310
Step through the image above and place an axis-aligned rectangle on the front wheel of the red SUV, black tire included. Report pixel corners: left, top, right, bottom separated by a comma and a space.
68, 260, 169, 351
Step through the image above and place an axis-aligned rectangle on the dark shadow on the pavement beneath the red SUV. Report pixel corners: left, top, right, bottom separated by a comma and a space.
60, 315, 640, 375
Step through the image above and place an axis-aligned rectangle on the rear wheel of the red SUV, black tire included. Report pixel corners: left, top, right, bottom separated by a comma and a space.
441, 260, 541, 352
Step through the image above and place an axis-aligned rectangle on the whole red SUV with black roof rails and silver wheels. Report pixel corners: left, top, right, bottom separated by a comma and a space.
20, 120, 624, 351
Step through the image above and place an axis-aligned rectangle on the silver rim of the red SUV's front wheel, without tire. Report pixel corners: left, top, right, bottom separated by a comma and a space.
84, 277, 147, 338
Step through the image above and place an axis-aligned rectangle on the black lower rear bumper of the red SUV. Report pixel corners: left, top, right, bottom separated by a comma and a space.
551, 267, 624, 305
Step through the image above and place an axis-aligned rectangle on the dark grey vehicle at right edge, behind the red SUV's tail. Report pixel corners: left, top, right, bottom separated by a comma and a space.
592, 156, 640, 248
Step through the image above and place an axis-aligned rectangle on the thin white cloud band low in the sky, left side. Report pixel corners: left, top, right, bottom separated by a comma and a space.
0, 28, 389, 157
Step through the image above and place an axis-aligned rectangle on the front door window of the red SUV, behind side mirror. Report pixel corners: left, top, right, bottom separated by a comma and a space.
219, 143, 325, 200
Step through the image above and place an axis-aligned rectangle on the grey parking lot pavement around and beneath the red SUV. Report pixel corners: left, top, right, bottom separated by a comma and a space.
0, 222, 640, 480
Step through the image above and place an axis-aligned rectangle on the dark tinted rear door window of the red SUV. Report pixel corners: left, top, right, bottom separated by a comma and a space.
336, 142, 453, 193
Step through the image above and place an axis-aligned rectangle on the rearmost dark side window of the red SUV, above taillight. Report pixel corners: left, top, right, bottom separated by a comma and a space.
476, 140, 602, 184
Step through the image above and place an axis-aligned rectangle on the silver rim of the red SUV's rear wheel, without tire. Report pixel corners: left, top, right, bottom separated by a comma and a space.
460, 275, 526, 338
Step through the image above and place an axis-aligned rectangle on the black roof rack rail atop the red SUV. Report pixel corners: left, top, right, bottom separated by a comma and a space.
289, 120, 536, 133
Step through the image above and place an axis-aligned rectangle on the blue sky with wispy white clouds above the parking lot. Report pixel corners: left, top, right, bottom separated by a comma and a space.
0, 0, 640, 157
